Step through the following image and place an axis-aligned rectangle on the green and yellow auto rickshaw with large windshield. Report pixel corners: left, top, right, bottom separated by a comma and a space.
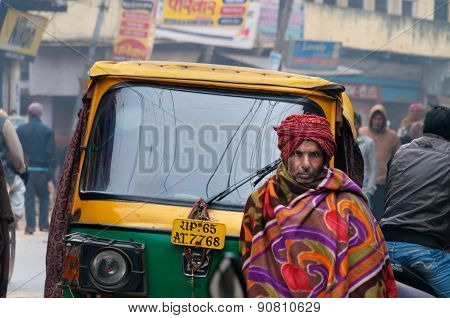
54, 62, 362, 297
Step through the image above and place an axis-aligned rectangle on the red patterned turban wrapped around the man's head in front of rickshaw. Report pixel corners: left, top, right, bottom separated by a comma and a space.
274, 115, 336, 162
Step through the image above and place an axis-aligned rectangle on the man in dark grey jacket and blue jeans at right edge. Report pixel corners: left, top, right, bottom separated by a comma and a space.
380, 106, 450, 297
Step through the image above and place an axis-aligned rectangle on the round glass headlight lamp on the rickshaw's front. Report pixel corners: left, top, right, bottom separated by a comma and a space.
90, 249, 130, 287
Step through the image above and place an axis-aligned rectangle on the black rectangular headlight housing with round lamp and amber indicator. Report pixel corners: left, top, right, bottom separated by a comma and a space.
62, 232, 147, 296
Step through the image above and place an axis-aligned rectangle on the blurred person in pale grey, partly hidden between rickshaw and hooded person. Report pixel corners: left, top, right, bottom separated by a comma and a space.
355, 113, 377, 206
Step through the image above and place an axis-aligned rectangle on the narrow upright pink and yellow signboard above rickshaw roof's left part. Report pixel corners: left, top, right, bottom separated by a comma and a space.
113, 0, 158, 60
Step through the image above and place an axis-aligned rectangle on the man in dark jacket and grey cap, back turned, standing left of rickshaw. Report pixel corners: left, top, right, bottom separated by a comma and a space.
17, 103, 55, 234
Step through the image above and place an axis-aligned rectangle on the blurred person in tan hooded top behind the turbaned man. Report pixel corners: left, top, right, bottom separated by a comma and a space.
359, 105, 400, 221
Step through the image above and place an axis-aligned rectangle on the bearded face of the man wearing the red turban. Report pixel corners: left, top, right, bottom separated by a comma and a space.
287, 140, 325, 184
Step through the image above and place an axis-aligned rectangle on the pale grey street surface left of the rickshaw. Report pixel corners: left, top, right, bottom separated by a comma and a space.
7, 218, 48, 298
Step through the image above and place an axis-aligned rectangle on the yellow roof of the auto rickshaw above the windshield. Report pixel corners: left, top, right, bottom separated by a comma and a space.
89, 61, 344, 95
